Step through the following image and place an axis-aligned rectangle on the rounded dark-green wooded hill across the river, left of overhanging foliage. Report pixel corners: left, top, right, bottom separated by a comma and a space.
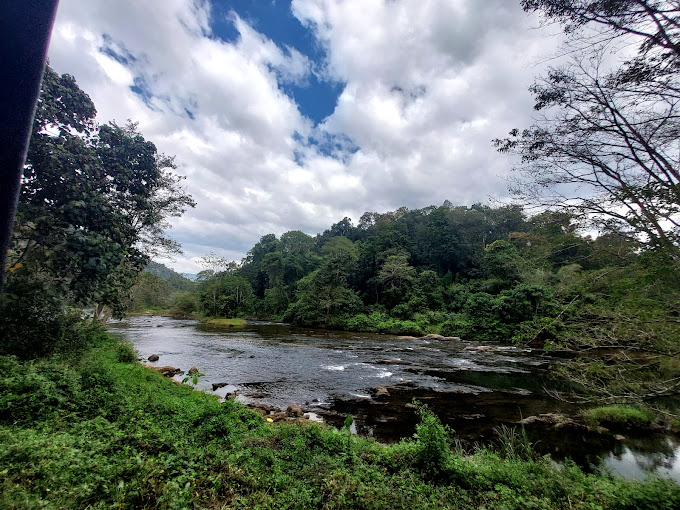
142, 202, 639, 341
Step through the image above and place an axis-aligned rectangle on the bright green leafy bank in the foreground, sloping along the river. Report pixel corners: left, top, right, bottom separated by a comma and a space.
0, 339, 680, 509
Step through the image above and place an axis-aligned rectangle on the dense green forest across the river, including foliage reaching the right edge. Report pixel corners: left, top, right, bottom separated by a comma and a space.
131, 199, 680, 402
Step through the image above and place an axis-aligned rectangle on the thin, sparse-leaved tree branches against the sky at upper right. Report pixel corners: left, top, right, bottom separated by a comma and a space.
495, 0, 680, 255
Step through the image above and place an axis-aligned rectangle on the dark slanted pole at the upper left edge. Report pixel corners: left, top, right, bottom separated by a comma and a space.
0, 0, 58, 293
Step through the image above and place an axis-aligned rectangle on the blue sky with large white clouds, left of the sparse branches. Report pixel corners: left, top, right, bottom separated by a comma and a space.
49, 0, 561, 273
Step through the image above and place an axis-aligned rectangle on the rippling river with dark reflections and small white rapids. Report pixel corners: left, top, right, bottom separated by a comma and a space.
110, 316, 680, 482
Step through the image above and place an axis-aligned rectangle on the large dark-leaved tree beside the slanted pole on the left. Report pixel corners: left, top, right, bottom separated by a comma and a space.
3, 67, 194, 315
